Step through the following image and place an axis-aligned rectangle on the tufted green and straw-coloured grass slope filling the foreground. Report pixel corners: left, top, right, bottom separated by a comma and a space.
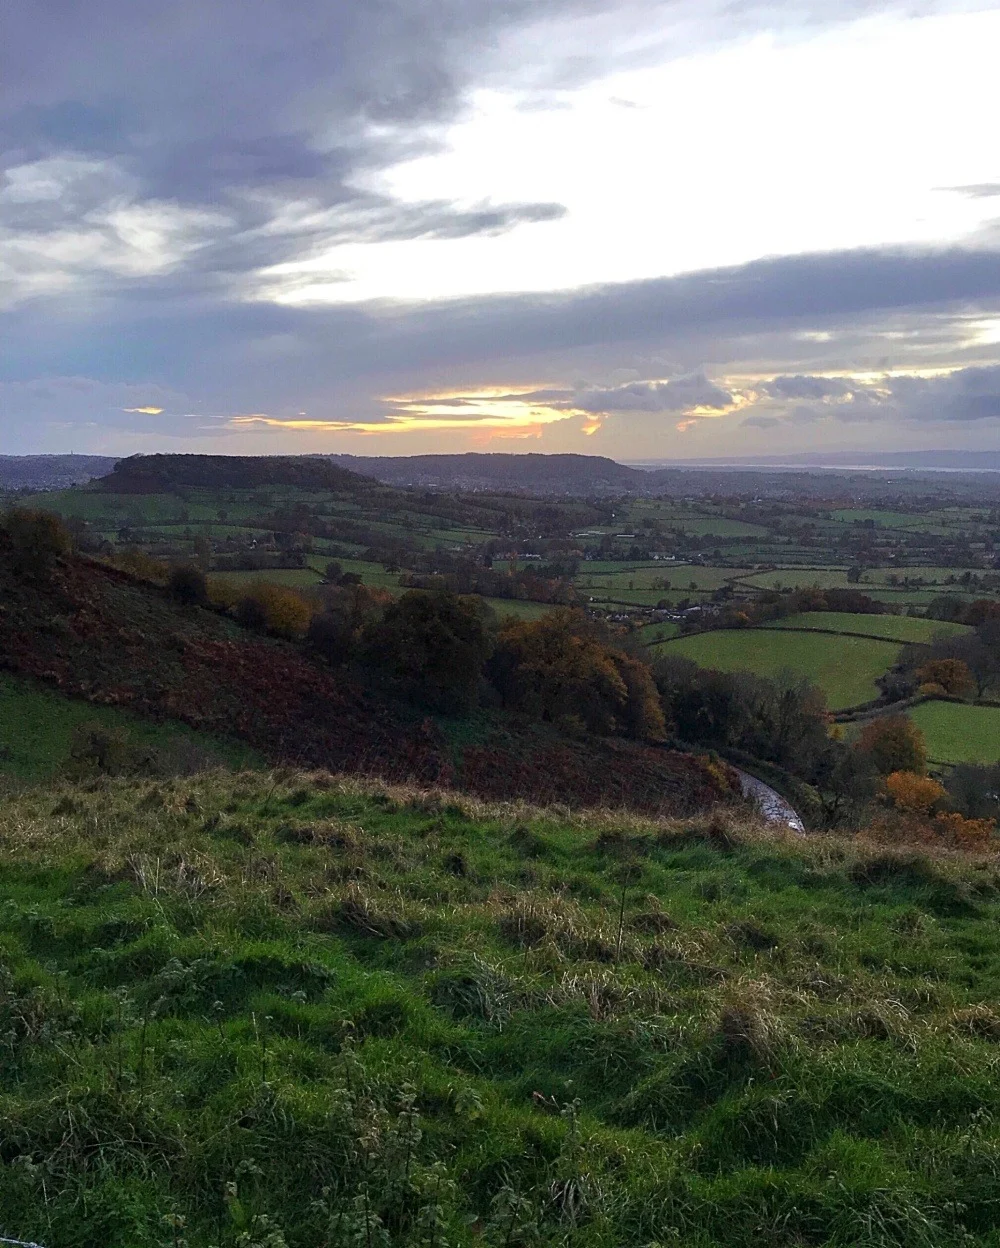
0, 773, 1000, 1248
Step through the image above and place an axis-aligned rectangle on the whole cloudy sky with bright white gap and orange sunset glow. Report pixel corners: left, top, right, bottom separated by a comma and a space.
0, 0, 1000, 461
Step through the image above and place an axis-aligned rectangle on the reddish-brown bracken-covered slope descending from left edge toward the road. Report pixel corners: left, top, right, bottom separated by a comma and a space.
0, 532, 735, 812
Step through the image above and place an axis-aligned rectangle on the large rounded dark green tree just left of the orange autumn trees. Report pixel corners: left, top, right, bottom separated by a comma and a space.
362, 590, 492, 714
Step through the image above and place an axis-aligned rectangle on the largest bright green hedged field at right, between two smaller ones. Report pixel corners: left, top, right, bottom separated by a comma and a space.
658, 629, 899, 710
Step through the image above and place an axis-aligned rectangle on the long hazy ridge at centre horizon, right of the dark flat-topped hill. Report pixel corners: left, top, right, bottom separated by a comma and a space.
330, 452, 648, 486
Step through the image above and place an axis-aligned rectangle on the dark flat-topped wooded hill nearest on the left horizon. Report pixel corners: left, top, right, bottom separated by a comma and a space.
100, 456, 375, 494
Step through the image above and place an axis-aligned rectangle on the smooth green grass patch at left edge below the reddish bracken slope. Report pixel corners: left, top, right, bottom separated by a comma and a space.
0, 673, 258, 782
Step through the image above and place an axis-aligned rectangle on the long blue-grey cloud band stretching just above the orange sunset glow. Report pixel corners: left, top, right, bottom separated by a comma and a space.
0, 248, 1000, 407
